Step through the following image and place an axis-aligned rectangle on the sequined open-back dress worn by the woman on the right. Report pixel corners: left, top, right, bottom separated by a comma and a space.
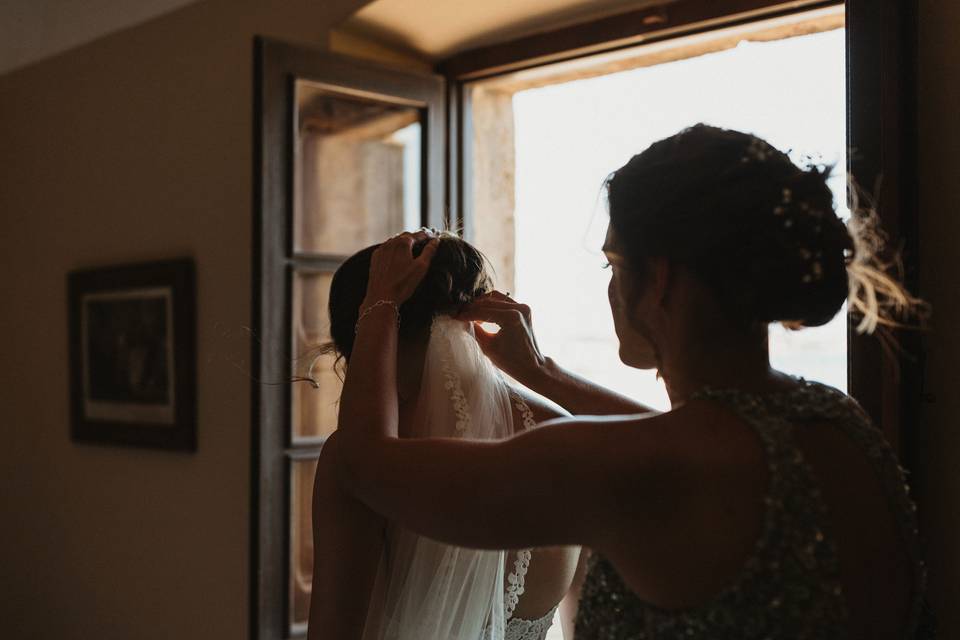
576, 380, 934, 640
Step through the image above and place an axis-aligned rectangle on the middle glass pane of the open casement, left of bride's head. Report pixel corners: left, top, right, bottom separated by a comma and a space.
290, 271, 342, 442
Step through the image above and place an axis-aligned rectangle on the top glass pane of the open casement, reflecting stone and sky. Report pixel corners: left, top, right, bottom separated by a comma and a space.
293, 80, 422, 255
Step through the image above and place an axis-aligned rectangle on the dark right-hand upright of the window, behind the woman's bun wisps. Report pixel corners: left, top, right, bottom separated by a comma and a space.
846, 0, 924, 468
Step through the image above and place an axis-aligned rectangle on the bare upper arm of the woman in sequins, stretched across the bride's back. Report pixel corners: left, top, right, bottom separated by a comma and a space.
338, 412, 675, 551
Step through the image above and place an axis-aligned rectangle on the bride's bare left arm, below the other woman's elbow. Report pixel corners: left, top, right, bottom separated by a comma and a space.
307, 446, 386, 640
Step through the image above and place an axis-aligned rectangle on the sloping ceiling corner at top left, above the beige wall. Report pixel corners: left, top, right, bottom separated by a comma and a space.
0, 0, 197, 74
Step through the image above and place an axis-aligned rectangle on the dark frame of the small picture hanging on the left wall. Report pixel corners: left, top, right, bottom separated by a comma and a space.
67, 259, 197, 451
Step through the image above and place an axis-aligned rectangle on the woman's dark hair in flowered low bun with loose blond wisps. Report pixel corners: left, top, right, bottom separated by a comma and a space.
606, 124, 921, 331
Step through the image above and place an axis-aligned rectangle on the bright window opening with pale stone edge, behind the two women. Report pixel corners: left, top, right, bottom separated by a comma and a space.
464, 6, 847, 410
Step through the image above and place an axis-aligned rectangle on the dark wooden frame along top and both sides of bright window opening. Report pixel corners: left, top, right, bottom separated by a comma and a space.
437, 0, 923, 456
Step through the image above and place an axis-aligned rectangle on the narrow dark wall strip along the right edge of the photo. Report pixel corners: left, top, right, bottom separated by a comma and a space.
915, 2, 960, 638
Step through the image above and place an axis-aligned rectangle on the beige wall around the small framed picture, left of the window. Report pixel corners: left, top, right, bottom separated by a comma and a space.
0, 0, 364, 640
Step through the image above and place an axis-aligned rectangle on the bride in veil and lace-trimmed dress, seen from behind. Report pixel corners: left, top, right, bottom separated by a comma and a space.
309, 233, 584, 640
